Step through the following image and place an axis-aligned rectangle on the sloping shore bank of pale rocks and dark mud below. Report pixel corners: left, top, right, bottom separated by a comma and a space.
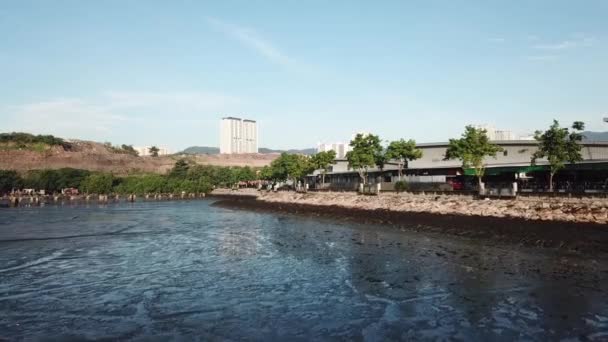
211, 192, 608, 253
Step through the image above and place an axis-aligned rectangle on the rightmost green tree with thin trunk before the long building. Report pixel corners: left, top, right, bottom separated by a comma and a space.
531, 120, 585, 191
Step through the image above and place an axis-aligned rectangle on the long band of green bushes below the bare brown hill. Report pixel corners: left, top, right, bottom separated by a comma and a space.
0, 160, 256, 204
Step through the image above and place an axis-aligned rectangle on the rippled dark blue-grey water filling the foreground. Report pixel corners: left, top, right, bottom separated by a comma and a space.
0, 200, 608, 341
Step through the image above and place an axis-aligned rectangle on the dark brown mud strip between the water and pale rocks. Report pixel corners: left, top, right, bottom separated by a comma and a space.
214, 196, 608, 255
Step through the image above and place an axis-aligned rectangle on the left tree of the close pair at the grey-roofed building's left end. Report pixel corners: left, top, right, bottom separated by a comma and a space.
346, 134, 384, 184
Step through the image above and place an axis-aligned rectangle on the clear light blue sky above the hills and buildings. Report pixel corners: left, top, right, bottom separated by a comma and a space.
0, 0, 608, 150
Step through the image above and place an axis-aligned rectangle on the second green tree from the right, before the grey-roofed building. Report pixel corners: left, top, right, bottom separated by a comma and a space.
444, 126, 503, 189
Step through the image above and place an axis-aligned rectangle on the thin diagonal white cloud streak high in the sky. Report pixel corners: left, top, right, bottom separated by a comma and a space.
207, 17, 295, 67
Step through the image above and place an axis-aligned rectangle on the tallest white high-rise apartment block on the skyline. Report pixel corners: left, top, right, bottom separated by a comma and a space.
220, 116, 258, 154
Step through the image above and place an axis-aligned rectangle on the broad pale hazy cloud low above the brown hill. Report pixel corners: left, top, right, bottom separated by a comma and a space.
0, 91, 240, 140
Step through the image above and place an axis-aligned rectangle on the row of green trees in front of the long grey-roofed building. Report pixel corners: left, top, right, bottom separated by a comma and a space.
261, 120, 584, 191
